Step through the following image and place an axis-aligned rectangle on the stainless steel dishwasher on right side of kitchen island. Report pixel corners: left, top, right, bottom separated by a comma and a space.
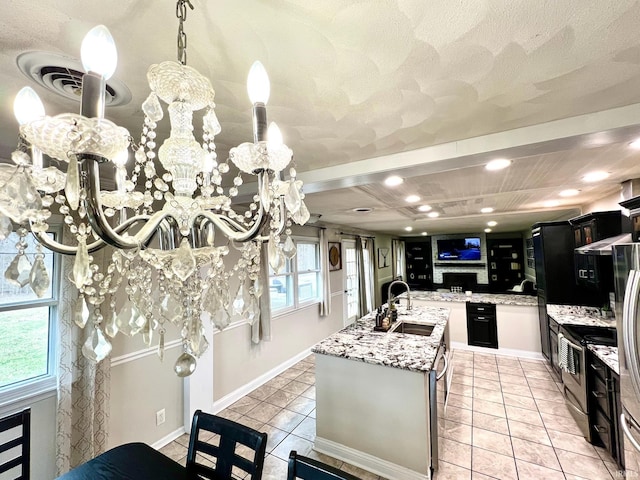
429, 338, 453, 474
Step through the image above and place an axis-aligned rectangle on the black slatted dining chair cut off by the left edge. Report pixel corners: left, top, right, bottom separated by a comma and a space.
0, 408, 31, 480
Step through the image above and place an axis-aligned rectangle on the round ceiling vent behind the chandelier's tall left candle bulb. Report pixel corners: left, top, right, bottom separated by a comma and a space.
17, 52, 131, 107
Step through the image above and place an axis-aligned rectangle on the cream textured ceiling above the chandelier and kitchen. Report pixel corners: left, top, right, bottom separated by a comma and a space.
0, 0, 640, 233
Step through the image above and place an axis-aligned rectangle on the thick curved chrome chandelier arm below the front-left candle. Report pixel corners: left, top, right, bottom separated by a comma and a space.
80, 156, 179, 250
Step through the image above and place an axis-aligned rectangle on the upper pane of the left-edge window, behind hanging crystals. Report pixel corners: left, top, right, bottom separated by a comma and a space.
0, 233, 53, 305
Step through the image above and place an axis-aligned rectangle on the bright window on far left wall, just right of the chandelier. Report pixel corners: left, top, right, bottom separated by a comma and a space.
269, 239, 320, 312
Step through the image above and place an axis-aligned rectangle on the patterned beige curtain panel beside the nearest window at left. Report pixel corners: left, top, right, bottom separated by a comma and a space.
56, 246, 111, 475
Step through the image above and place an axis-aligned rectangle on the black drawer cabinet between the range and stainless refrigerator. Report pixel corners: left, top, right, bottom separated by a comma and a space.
587, 351, 624, 468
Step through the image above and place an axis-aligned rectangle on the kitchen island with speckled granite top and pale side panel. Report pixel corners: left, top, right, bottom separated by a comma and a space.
312, 306, 449, 480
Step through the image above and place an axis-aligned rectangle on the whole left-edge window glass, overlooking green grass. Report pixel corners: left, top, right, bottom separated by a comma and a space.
0, 233, 58, 396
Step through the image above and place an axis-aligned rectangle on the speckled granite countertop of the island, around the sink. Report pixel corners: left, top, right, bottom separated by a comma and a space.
311, 306, 449, 373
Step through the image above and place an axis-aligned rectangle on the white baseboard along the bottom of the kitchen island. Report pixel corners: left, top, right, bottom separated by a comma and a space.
313, 436, 431, 480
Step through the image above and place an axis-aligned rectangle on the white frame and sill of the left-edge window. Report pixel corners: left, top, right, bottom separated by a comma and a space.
0, 225, 63, 408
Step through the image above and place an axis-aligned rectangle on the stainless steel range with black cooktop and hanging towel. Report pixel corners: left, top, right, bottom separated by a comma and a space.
558, 325, 617, 442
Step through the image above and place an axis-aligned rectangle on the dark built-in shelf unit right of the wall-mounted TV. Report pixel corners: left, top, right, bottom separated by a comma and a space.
487, 238, 525, 293
